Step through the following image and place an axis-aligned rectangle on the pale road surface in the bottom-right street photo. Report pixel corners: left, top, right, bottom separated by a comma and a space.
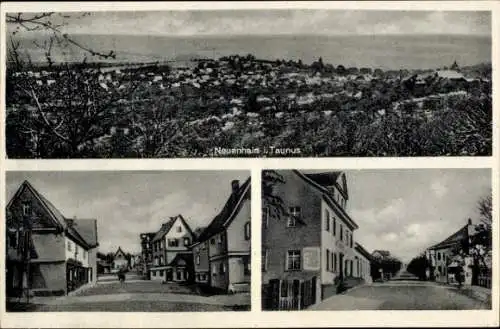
310, 281, 490, 310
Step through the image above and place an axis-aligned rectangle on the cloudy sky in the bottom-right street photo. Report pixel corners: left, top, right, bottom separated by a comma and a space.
340, 169, 491, 262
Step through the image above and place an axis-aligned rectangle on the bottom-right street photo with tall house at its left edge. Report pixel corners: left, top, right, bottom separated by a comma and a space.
261, 169, 493, 311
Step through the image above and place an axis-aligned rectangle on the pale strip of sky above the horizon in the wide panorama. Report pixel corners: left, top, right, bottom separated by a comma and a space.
7, 9, 491, 36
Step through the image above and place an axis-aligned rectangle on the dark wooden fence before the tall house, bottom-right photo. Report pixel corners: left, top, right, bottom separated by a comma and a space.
262, 277, 317, 311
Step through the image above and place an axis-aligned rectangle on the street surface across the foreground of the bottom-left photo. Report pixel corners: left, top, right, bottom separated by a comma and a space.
9, 281, 254, 312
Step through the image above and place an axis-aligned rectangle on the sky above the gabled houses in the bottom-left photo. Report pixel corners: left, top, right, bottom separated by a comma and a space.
6, 170, 250, 253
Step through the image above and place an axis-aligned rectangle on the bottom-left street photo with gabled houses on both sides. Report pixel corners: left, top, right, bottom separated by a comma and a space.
3, 170, 251, 312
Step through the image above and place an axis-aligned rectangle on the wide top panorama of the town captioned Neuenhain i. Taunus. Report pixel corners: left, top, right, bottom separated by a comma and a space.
3, 9, 493, 159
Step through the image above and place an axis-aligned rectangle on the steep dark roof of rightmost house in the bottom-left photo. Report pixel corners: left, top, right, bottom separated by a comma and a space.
197, 177, 250, 242
